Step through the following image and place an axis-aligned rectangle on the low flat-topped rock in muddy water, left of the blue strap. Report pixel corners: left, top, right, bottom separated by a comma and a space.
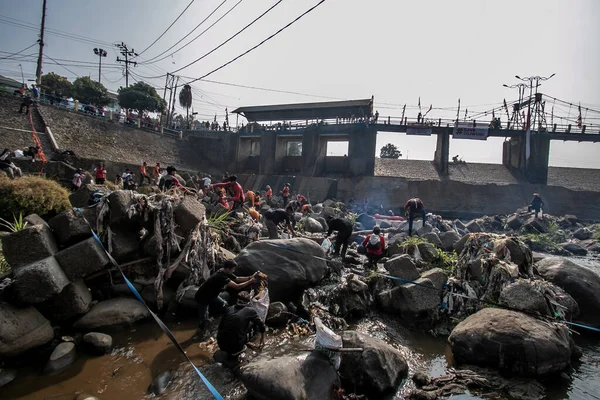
73, 298, 150, 330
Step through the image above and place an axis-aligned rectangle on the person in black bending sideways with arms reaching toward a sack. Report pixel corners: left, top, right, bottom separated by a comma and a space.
194, 260, 256, 330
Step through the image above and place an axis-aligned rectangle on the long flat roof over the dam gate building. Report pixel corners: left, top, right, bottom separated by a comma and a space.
233, 99, 373, 122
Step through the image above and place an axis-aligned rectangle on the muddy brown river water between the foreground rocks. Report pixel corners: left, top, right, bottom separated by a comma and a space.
0, 259, 600, 400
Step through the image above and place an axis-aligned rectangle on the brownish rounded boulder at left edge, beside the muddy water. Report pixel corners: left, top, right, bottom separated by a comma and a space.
0, 302, 54, 359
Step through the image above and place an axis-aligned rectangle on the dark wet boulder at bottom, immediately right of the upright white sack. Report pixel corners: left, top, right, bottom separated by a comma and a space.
340, 331, 408, 399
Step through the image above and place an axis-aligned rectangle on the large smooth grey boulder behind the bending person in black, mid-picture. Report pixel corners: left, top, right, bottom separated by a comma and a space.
235, 238, 327, 303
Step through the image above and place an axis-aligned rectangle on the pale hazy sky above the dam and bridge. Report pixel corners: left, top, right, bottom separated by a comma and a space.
0, 0, 600, 168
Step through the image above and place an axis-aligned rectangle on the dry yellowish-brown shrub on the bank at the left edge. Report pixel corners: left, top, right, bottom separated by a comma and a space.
0, 176, 71, 221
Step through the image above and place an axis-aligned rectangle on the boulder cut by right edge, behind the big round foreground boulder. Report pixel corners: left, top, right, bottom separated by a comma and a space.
537, 257, 600, 326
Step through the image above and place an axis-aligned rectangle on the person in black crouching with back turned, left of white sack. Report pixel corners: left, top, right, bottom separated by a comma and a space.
217, 293, 265, 362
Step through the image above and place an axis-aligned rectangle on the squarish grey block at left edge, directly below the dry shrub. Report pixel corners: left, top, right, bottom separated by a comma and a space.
2, 224, 58, 271
